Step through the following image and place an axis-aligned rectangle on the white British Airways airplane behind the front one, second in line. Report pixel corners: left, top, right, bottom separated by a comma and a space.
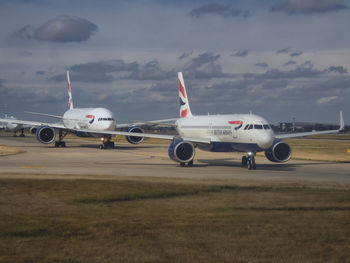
0, 71, 149, 149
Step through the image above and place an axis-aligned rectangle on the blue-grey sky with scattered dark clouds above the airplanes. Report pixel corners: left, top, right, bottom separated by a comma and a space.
0, 0, 350, 123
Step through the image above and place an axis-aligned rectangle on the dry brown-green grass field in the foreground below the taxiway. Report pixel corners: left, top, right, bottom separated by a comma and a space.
0, 176, 350, 262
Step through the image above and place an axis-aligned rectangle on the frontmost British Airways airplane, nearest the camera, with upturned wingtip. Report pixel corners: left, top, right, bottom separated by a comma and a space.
83, 72, 345, 169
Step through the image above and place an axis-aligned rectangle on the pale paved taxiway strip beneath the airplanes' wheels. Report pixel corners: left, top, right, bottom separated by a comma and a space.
0, 134, 350, 186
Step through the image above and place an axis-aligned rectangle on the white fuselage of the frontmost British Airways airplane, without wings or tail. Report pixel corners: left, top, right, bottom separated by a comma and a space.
176, 114, 274, 152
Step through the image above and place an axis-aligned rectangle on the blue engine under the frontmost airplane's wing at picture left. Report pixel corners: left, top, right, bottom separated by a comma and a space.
168, 139, 195, 163
